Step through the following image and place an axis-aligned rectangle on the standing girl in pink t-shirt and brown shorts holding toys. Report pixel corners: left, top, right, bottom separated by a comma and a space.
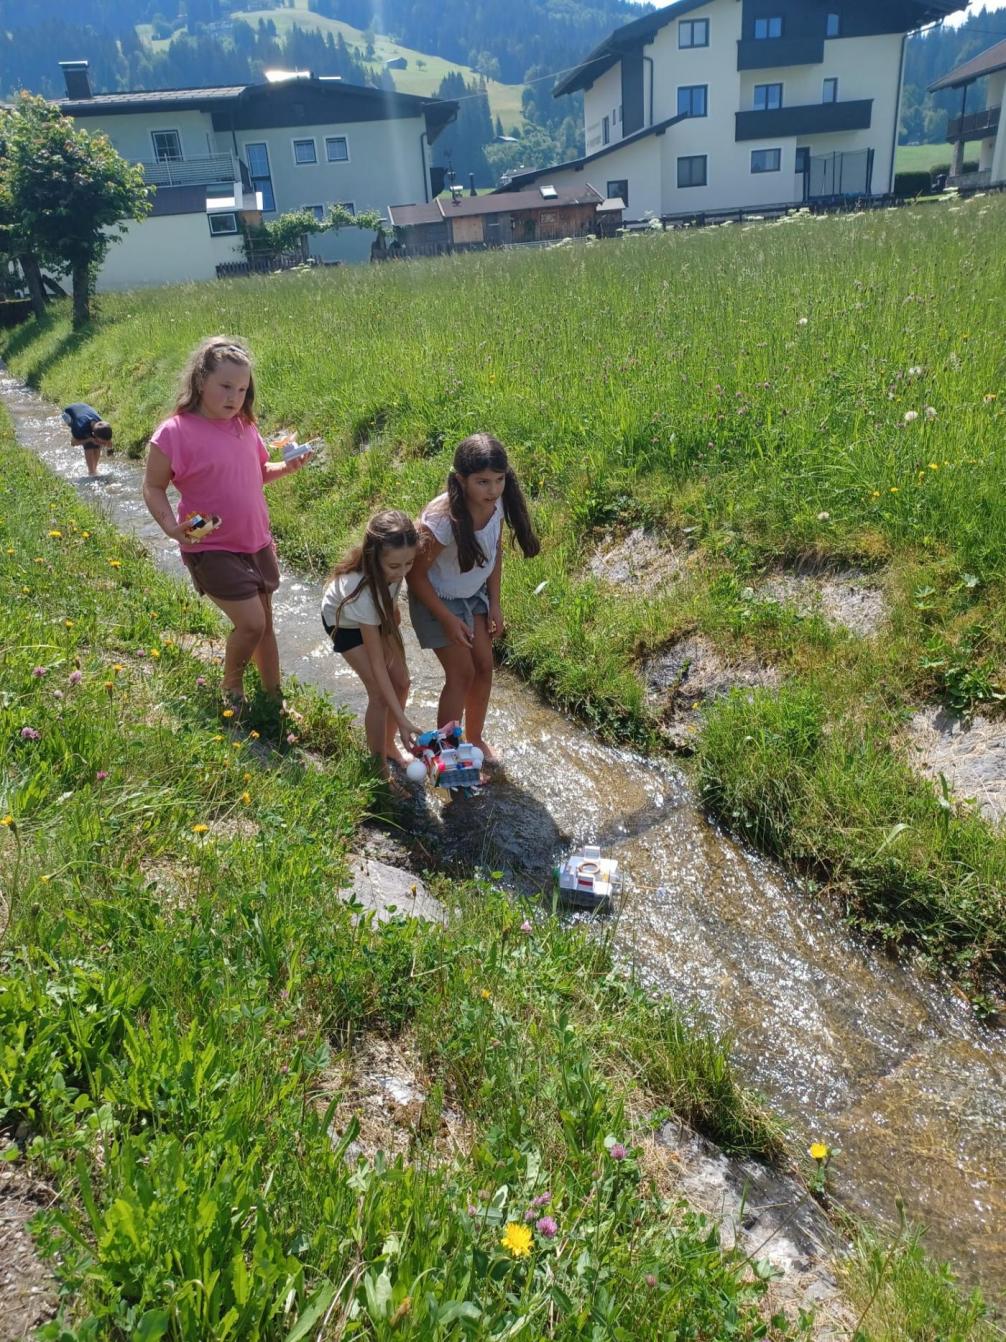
144, 336, 310, 713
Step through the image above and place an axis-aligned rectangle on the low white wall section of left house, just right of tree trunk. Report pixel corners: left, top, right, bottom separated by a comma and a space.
97, 215, 244, 294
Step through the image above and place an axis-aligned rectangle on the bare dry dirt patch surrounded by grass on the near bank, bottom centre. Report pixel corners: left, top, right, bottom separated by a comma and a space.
321, 1033, 472, 1161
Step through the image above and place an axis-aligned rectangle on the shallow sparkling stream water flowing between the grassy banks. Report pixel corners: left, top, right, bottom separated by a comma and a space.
0, 374, 1006, 1294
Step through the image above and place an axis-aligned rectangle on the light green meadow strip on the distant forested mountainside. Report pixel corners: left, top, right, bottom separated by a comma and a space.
137, 0, 524, 132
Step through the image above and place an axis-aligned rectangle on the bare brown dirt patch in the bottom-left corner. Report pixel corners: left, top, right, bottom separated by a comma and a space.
0, 1162, 58, 1342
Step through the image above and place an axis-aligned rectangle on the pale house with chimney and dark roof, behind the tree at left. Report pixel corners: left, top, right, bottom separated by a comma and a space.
58, 60, 457, 290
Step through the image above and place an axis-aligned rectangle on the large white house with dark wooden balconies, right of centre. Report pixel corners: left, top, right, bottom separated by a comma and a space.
503, 0, 964, 219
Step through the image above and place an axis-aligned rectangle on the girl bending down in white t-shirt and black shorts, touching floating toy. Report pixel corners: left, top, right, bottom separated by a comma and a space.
322, 509, 418, 776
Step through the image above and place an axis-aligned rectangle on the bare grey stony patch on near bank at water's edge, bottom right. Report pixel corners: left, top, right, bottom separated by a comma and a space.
640, 1123, 856, 1342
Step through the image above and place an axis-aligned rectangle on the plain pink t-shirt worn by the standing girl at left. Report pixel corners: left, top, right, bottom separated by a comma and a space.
150, 413, 272, 554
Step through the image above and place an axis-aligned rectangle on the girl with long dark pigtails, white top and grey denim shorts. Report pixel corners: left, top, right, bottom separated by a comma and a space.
409, 433, 541, 764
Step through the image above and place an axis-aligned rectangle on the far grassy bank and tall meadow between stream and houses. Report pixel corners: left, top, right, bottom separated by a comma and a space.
4, 197, 1006, 1002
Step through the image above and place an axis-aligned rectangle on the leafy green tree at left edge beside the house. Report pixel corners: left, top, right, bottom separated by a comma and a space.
0, 94, 152, 330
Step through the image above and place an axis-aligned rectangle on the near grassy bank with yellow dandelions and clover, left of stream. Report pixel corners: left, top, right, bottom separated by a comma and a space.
0, 429, 806, 1342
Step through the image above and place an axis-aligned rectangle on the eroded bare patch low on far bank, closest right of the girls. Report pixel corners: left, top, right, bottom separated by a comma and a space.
642, 635, 781, 750
